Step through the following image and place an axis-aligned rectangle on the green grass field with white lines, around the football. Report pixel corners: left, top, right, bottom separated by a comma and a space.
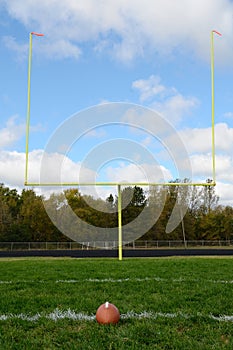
0, 258, 233, 350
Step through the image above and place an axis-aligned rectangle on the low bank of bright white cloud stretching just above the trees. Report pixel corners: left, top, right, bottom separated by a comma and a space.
0, 145, 233, 205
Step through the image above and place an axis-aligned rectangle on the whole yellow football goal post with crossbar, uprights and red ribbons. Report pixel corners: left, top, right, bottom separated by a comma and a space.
24, 30, 221, 260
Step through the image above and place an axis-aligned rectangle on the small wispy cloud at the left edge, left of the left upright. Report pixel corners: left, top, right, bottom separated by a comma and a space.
0, 116, 25, 149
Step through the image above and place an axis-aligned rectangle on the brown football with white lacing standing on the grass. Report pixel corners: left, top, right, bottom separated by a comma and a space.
96, 301, 120, 324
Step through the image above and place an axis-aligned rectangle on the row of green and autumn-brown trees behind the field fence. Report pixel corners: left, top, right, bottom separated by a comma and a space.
0, 179, 233, 242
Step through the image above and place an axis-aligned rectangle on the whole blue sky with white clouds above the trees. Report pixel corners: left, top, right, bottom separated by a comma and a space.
0, 0, 233, 205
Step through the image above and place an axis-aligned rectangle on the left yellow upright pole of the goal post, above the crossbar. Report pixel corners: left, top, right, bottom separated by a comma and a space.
24, 33, 32, 185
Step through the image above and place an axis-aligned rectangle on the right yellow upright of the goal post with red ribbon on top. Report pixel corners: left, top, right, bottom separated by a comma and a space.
210, 30, 221, 184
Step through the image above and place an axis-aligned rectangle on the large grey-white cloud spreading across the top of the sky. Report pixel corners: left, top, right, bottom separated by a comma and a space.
4, 0, 233, 63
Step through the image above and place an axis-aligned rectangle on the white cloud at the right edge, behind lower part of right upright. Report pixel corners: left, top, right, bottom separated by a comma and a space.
179, 123, 233, 194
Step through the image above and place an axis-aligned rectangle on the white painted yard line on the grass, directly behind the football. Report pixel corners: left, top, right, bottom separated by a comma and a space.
0, 309, 233, 322
